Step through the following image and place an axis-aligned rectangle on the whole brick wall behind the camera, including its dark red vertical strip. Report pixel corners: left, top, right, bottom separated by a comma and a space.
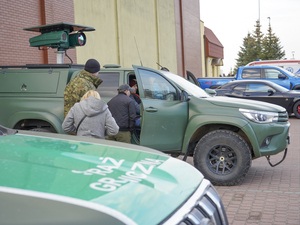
0, 0, 76, 65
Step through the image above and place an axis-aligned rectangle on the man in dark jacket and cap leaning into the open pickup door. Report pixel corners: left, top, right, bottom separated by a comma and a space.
107, 84, 136, 143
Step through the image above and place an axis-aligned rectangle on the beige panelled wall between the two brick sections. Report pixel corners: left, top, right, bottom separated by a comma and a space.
74, 0, 177, 73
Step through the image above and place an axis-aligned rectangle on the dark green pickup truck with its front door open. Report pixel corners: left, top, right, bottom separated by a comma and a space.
0, 24, 290, 185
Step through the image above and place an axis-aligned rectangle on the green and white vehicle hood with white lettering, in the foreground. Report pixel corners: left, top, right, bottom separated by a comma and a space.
0, 126, 228, 225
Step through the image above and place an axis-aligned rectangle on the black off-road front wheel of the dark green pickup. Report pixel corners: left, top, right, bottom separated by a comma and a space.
194, 130, 252, 186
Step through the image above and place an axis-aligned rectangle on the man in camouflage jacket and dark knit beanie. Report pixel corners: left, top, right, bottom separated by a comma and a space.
64, 59, 102, 117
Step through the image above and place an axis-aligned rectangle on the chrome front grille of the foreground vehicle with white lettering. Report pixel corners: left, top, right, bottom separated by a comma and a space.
163, 179, 228, 225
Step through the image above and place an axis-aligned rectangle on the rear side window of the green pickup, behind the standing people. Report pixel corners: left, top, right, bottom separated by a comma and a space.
97, 72, 120, 98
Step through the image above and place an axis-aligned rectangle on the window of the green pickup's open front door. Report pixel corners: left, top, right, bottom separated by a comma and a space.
139, 69, 178, 101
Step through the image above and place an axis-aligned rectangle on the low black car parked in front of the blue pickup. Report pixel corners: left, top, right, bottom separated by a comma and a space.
215, 80, 300, 119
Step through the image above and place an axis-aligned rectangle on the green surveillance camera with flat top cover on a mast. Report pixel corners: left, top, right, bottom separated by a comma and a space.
24, 23, 95, 64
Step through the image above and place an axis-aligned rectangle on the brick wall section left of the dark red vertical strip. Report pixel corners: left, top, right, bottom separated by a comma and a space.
0, 0, 42, 65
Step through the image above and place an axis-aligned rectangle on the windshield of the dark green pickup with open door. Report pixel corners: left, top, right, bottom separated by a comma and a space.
160, 71, 211, 98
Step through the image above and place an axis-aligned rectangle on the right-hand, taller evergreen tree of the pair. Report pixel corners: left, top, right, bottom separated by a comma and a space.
261, 23, 285, 60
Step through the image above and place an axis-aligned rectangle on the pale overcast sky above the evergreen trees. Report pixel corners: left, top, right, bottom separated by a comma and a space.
199, 0, 300, 74
